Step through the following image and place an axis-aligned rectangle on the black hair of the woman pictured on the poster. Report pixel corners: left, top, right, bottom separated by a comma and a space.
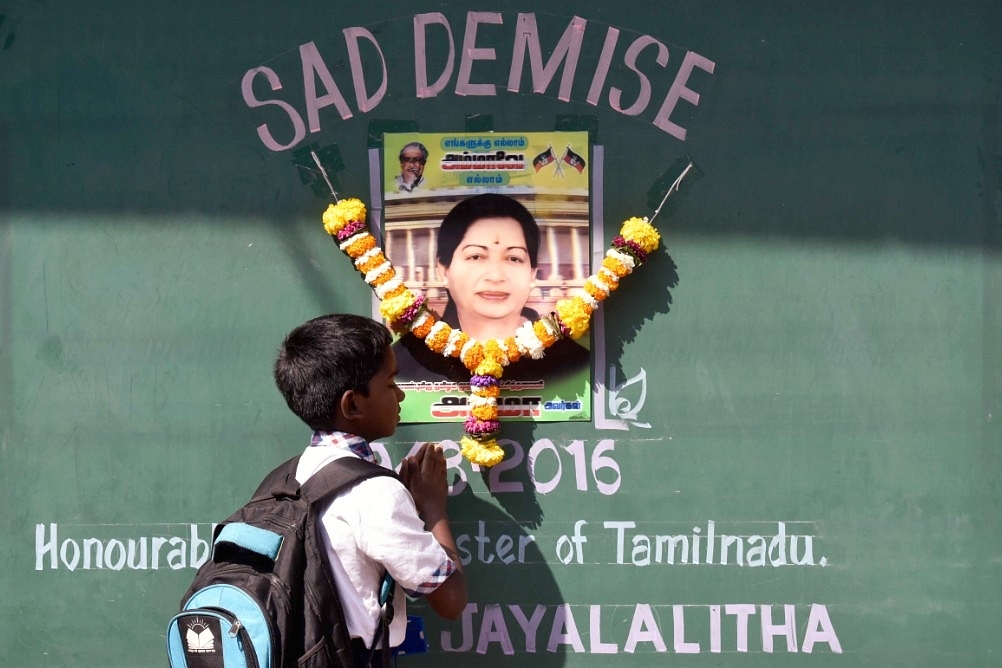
436, 192, 539, 268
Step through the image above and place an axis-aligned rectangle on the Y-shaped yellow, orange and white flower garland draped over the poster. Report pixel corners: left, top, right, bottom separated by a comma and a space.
324, 197, 661, 467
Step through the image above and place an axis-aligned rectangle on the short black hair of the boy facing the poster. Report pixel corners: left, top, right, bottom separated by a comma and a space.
275, 313, 392, 432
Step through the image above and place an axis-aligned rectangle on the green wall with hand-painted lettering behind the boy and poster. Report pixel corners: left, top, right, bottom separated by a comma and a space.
0, 0, 1002, 668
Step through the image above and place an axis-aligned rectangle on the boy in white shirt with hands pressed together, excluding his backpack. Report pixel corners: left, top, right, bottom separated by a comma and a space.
275, 313, 467, 666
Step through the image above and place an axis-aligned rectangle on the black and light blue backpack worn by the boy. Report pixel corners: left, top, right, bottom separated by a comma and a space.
167, 457, 396, 668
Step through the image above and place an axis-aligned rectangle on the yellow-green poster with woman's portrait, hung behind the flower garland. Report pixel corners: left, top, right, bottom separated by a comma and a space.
380, 132, 591, 423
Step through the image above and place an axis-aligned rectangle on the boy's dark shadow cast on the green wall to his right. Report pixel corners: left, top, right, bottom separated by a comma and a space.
399, 421, 567, 668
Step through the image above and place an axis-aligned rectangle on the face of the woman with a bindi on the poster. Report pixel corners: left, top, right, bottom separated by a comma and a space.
438, 217, 536, 336
